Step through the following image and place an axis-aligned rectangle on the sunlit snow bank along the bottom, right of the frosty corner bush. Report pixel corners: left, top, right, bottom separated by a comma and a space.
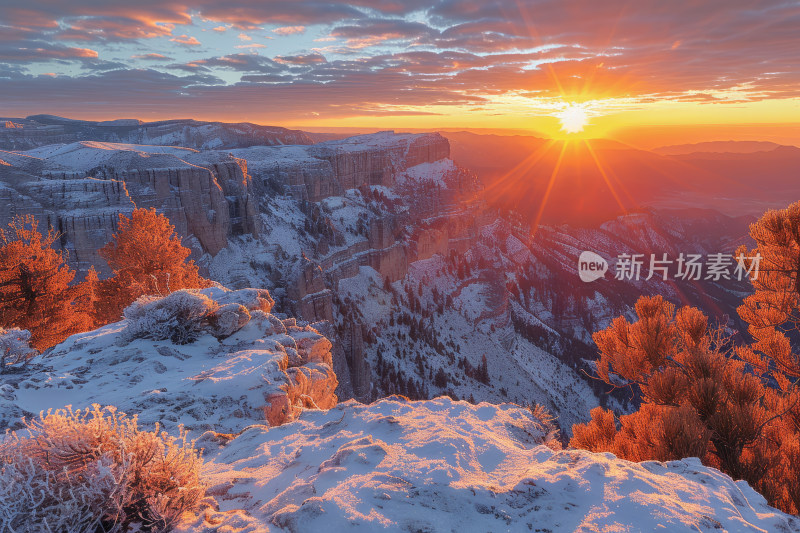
191, 398, 800, 533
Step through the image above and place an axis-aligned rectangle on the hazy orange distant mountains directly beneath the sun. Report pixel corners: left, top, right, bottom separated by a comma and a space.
443, 132, 800, 225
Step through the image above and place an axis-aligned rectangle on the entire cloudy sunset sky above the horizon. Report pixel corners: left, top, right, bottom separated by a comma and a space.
0, 0, 800, 143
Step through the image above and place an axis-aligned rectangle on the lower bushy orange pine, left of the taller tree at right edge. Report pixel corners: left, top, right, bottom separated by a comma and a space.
570, 290, 800, 513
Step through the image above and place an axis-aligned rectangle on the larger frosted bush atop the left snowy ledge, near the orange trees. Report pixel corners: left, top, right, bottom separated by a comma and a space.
123, 289, 218, 344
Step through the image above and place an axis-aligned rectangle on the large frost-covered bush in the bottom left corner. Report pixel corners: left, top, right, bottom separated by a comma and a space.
0, 405, 205, 533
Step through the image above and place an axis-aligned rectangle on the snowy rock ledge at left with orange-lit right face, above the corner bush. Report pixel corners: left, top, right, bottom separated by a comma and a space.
0, 287, 338, 436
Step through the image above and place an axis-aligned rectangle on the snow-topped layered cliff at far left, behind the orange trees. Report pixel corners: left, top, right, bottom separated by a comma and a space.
0, 141, 258, 273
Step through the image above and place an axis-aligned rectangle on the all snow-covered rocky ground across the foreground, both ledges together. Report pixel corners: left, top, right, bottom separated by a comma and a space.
0, 286, 800, 533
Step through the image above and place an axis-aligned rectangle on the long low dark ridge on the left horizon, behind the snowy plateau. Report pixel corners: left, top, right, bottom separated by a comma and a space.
0, 115, 313, 150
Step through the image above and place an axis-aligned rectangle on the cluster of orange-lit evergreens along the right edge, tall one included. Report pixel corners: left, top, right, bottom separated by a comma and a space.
570, 202, 800, 514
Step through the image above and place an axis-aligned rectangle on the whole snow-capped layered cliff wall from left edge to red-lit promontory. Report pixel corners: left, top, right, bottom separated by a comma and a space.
0, 130, 485, 404
